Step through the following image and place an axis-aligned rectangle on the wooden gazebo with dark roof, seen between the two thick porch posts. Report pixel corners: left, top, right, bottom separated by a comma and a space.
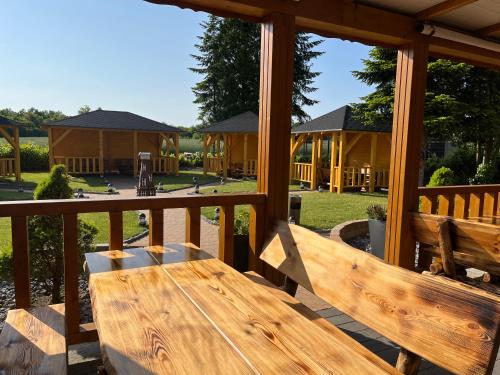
290, 105, 391, 193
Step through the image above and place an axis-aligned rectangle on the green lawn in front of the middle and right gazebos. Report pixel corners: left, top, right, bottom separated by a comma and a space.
202, 181, 387, 229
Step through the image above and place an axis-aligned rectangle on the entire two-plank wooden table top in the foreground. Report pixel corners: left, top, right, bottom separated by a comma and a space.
85, 244, 396, 374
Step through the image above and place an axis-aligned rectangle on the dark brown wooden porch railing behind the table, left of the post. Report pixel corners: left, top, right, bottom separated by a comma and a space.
0, 193, 266, 344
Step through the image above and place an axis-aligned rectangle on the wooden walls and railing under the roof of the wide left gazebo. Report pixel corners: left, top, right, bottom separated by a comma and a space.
47, 126, 179, 176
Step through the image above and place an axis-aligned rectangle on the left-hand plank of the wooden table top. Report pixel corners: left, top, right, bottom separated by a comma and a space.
86, 249, 253, 374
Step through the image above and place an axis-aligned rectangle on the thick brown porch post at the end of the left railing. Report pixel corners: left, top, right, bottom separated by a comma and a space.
256, 14, 295, 285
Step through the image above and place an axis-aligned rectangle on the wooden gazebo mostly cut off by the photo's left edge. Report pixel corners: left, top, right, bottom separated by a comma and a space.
0, 116, 21, 182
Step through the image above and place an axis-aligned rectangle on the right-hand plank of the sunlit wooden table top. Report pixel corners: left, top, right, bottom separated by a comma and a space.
150, 248, 398, 374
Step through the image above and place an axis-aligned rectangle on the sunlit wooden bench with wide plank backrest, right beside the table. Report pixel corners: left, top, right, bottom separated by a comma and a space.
252, 222, 500, 374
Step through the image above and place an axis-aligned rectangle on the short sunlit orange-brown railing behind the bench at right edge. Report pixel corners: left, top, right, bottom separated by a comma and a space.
418, 185, 500, 222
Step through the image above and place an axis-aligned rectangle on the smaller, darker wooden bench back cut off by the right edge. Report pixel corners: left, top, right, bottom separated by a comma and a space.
411, 213, 500, 277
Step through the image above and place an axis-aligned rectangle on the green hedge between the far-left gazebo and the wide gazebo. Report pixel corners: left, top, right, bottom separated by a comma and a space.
0, 143, 49, 172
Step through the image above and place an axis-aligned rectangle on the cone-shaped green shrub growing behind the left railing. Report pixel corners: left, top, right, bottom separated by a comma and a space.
29, 165, 97, 303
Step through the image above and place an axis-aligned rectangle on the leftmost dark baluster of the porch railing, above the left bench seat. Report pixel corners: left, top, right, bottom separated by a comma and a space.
11, 216, 31, 308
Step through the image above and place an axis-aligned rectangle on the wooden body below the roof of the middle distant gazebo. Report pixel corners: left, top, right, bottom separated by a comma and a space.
203, 133, 258, 177
